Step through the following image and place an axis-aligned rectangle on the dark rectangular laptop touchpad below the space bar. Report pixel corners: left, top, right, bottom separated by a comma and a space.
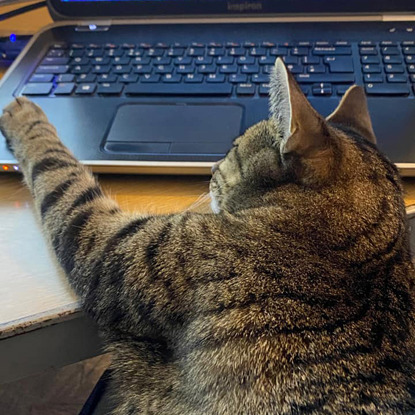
104, 104, 244, 155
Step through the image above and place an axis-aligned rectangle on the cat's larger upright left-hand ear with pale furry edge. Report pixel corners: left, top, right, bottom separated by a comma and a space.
270, 58, 327, 156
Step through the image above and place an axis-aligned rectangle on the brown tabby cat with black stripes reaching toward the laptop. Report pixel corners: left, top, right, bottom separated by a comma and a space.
0, 60, 415, 415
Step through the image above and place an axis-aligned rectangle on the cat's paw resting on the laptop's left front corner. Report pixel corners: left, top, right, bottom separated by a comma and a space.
0, 97, 49, 150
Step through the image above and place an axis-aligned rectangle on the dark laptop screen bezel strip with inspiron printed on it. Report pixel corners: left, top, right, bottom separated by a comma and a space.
48, 0, 415, 19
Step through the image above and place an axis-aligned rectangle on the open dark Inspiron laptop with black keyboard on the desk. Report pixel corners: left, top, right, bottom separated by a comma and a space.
0, 0, 415, 176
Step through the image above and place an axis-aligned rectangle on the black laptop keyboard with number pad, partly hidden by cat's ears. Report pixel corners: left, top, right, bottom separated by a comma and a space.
21, 41, 415, 97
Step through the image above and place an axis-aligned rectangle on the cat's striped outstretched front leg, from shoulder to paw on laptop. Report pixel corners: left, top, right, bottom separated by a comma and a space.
0, 98, 208, 338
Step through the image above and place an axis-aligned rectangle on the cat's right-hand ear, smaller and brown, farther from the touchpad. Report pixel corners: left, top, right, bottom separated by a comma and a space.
327, 85, 376, 143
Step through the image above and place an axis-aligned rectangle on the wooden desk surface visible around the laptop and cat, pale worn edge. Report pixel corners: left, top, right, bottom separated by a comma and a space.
0, 7, 415, 338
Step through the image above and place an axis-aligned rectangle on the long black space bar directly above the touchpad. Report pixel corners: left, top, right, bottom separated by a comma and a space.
124, 83, 232, 96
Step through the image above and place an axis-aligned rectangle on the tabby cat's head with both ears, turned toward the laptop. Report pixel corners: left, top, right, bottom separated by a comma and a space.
210, 59, 402, 212
